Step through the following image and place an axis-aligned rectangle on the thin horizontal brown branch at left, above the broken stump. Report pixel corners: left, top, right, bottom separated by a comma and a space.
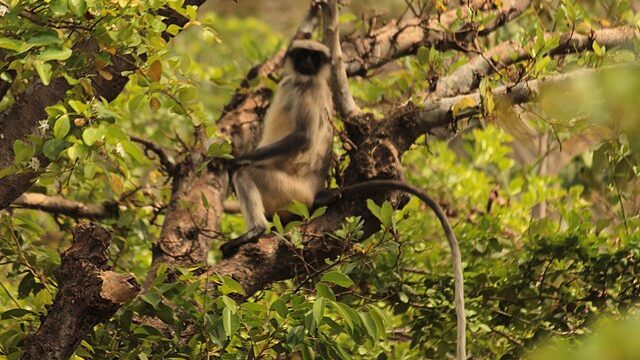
11, 193, 119, 219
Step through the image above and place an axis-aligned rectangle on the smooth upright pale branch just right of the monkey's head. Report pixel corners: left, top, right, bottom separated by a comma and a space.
322, 0, 361, 119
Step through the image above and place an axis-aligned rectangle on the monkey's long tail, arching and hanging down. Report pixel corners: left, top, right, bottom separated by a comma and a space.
339, 180, 467, 360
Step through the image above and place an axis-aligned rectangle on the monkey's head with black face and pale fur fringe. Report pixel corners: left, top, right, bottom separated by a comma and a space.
287, 40, 330, 76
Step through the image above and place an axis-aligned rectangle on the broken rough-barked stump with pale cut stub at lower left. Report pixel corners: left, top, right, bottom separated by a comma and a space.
22, 223, 139, 360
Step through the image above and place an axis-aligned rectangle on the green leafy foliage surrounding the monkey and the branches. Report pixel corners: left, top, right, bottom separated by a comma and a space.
0, 0, 640, 359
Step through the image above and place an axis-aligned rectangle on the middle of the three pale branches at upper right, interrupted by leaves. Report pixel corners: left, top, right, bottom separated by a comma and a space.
430, 27, 640, 98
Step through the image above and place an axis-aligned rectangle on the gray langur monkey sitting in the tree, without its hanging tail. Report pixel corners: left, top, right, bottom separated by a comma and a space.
220, 40, 333, 257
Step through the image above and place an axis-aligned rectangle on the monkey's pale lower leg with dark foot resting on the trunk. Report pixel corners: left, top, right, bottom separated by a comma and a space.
220, 168, 267, 257
